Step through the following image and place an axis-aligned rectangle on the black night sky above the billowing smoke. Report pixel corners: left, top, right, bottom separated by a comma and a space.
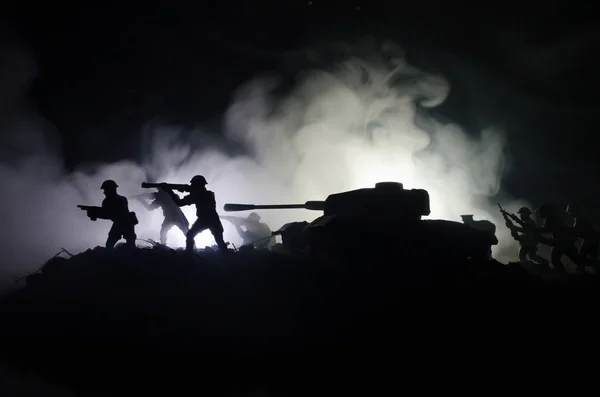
4, 0, 600, 210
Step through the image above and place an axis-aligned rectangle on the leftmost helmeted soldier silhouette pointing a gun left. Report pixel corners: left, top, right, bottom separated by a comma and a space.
77, 179, 138, 248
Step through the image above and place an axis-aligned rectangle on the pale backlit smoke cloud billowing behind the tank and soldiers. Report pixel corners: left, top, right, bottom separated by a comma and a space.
0, 38, 517, 286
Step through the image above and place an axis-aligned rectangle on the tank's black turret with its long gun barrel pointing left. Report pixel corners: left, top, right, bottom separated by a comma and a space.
223, 182, 431, 220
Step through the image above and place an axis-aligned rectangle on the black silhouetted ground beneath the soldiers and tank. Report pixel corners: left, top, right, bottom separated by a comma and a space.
0, 247, 600, 396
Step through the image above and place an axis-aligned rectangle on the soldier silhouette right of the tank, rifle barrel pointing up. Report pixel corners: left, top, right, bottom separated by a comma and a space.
498, 203, 548, 265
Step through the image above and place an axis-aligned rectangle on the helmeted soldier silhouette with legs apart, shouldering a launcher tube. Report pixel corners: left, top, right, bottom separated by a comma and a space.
159, 175, 227, 252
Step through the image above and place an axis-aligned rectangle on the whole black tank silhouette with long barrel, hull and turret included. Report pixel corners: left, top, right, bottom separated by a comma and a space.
223, 182, 497, 259
